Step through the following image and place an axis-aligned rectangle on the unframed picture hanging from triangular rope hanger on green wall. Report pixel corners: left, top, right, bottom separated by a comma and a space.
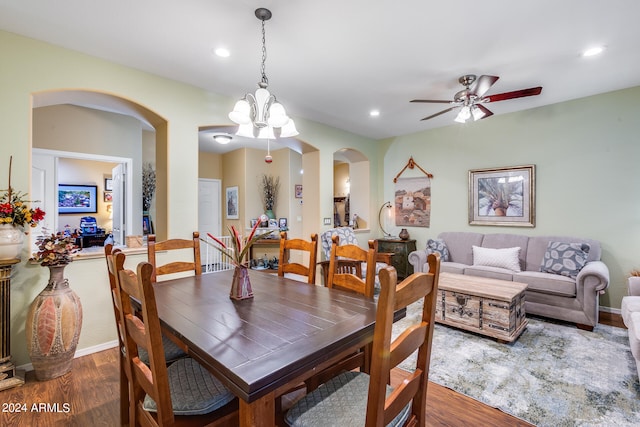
393, 157, 433, 227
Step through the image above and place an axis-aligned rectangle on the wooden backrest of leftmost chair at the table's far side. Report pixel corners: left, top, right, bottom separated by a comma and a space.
147, 231, 202, 282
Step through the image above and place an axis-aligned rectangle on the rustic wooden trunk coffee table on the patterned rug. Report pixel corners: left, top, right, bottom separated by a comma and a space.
436, 273, 528, 342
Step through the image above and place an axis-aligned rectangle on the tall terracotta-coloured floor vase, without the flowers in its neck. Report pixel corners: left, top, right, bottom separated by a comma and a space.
26, 265, 82, 381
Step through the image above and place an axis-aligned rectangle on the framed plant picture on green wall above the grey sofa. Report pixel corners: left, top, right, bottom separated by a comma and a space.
469, 165, 536, 227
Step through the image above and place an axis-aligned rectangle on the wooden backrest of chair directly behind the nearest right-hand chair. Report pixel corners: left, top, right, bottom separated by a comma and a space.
325, 235, 376, 298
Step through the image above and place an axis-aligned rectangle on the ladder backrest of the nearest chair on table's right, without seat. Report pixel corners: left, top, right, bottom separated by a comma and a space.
366, 254, 440, 426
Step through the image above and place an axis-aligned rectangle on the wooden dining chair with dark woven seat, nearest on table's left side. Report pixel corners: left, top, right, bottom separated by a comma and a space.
113, 252, 239, 426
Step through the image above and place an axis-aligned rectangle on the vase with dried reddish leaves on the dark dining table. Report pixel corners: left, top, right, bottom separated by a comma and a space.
205, 222, 272, 300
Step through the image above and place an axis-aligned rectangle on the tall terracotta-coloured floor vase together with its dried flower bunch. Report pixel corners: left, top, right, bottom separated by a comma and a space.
25, 233, 82, 381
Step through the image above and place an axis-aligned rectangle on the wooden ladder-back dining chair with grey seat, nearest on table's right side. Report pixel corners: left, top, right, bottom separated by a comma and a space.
285, 254, 440, 427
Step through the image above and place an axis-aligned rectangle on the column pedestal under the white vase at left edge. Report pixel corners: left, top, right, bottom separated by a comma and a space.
0, 259, 24, 390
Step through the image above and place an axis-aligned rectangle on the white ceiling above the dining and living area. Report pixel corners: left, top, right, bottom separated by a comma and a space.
0, 0, 640, 153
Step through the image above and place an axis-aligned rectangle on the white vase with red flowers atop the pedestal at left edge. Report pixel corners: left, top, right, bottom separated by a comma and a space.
0, 156, 45, 261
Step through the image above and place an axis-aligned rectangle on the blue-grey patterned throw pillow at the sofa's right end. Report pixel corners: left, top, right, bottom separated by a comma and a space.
540, 242, 591, 279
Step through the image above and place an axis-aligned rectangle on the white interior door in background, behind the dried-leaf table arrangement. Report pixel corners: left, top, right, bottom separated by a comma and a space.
198, 178, 222, 265
